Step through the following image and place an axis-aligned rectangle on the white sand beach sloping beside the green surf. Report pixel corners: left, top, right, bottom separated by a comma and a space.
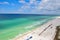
13, 17, 60, 40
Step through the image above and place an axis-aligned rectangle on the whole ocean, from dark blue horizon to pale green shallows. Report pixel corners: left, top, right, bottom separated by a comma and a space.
0, 14, 53, 40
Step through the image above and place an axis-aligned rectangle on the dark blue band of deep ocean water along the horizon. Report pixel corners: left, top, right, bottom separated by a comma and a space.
0, 14, 57, 20
